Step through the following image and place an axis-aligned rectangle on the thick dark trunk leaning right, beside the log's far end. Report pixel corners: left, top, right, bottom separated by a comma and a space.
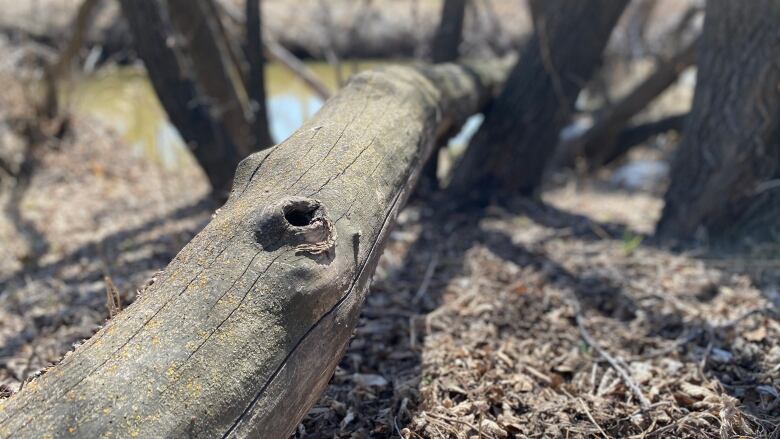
451, 0, 627, 194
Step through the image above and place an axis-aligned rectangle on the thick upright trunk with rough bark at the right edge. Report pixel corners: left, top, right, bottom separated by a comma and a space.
657, 0, 780, 239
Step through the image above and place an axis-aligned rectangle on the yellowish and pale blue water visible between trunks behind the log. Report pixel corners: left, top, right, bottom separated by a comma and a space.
67, 61, 481, 168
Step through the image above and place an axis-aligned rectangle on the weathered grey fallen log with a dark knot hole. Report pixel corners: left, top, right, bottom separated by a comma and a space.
0, 63, 509, 439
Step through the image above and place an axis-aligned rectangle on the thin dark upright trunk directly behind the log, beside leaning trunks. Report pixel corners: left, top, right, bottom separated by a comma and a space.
246, 0, 273, 150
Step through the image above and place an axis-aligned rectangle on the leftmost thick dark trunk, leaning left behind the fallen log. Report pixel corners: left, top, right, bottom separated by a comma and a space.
121, 0, 245, 195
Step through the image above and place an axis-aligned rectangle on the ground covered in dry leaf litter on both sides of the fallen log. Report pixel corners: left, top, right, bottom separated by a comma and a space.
0, 112, 780, 438
